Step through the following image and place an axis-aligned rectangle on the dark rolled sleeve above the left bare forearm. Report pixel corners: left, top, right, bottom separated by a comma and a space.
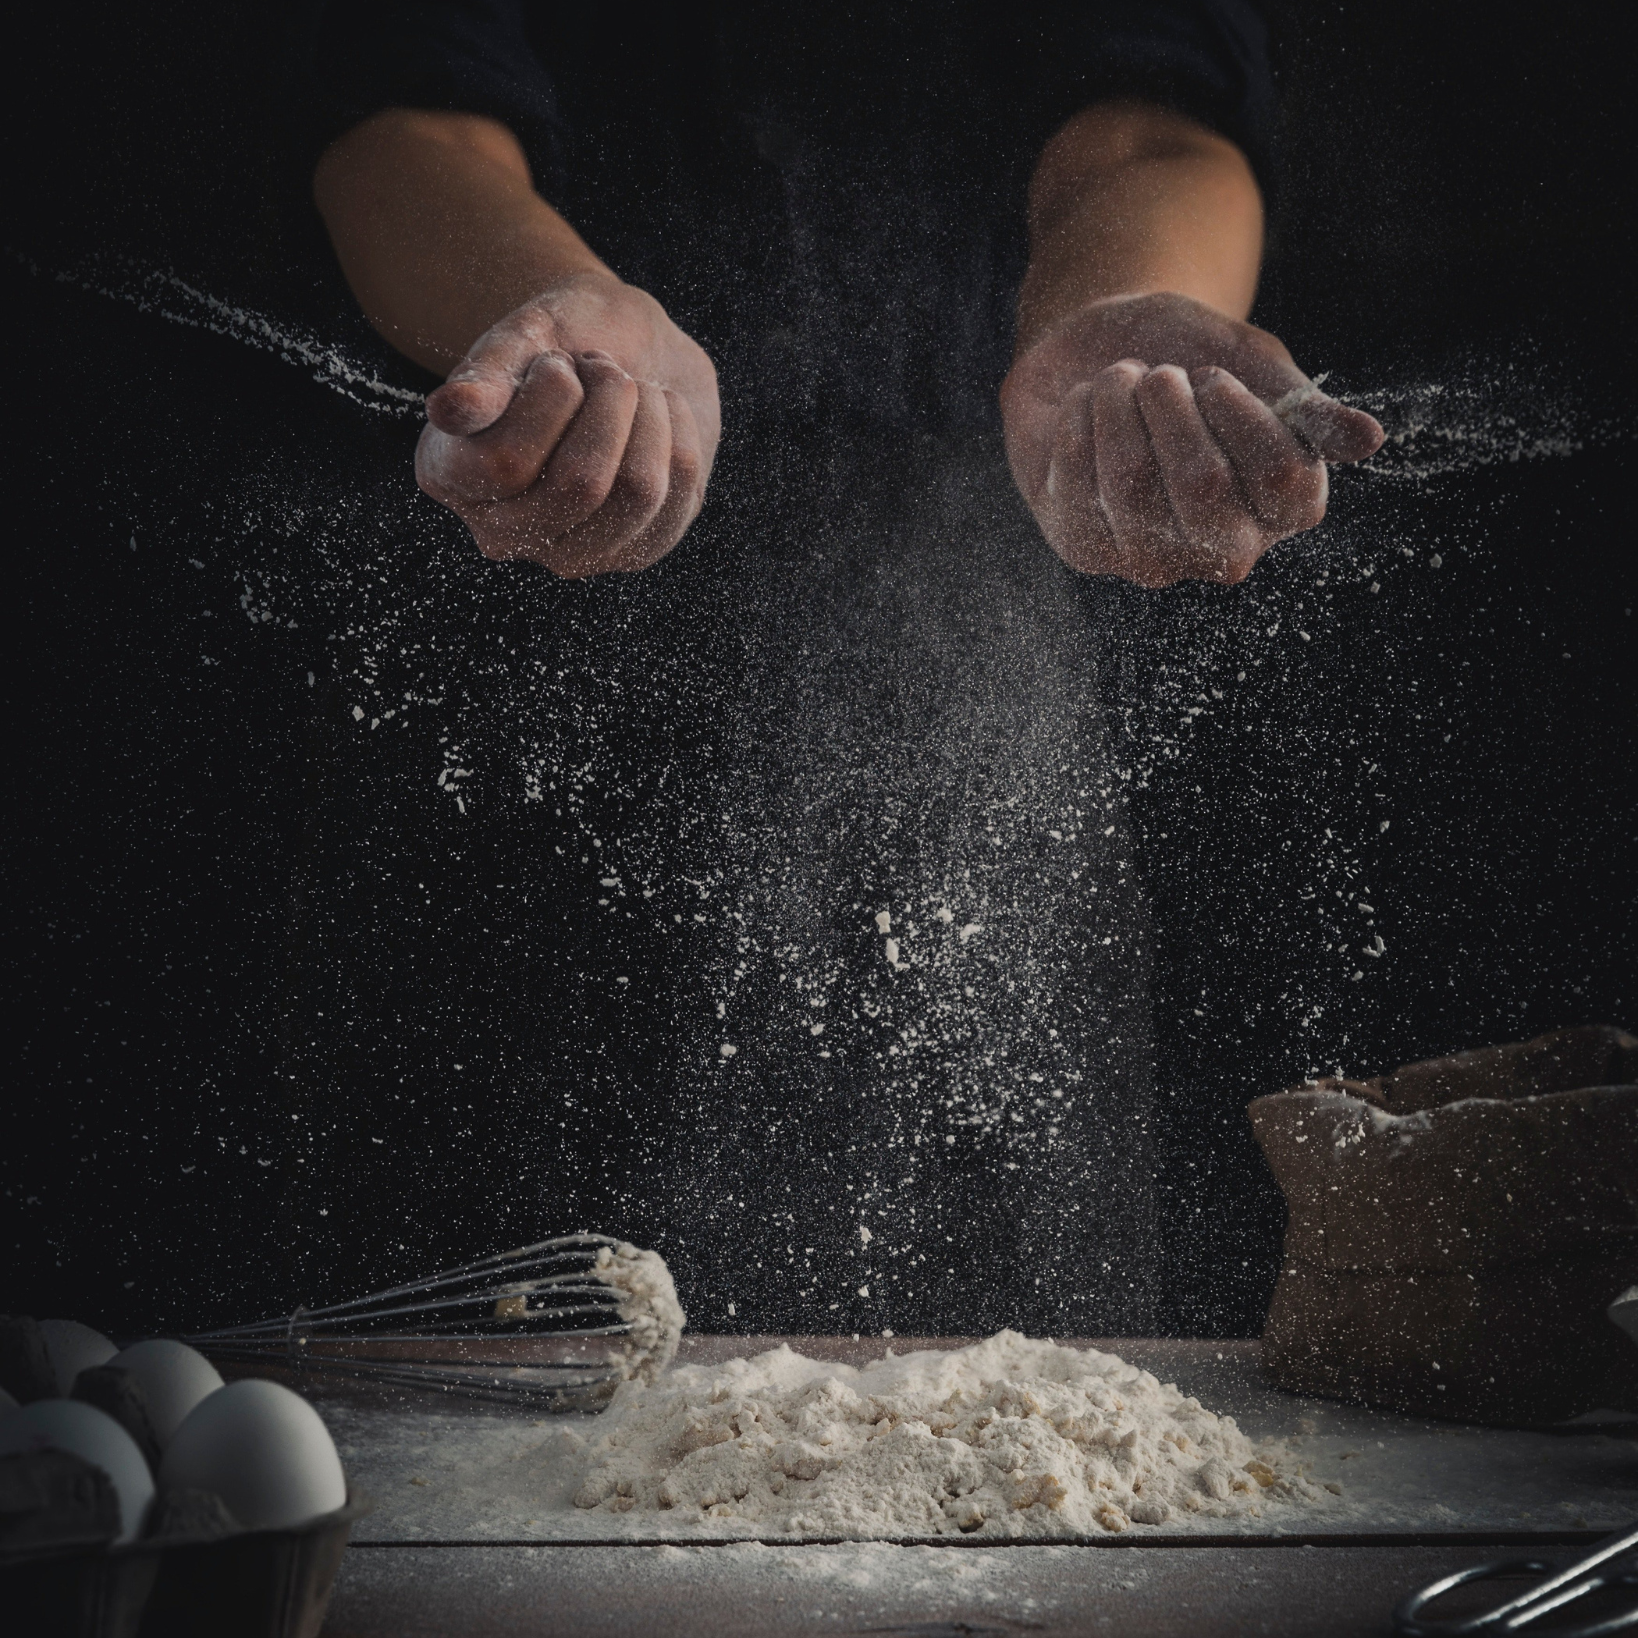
278, 0, 563, 187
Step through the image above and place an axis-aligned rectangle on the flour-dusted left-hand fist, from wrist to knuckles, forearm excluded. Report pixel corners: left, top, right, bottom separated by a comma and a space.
414, 274, 721, 580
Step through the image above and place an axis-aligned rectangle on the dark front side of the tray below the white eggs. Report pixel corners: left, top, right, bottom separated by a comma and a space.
0, 1489, 370, 1638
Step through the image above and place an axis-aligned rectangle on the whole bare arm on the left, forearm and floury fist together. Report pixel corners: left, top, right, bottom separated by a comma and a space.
313, 108, 721, 577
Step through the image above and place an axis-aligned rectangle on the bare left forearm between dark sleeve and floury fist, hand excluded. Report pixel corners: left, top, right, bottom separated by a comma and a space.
313, 108, 614, 375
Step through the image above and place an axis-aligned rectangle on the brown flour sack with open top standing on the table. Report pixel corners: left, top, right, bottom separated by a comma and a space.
1250, 1027, 1638, 1423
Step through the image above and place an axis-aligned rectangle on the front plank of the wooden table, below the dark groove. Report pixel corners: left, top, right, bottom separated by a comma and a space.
324, 1543, 1563, 1638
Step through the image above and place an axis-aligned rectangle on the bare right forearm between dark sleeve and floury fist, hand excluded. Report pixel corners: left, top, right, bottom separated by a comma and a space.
1017, 103, 1263, 352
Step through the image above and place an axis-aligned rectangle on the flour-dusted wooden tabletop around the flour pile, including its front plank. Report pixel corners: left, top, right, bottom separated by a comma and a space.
314, 1337, 1638, 1638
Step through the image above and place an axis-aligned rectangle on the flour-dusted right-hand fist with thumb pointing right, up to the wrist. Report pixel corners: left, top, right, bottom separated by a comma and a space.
1001, 295, 1382, 586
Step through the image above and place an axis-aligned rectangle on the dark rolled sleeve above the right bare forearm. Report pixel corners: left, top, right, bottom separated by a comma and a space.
995, 0, 1278, 190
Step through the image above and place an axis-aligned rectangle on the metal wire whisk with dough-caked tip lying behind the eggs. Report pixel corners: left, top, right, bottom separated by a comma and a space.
187, 1233, 683, 1410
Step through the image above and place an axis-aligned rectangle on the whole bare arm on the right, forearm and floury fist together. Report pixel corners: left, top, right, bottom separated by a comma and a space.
1001, 102, 1382, 585
